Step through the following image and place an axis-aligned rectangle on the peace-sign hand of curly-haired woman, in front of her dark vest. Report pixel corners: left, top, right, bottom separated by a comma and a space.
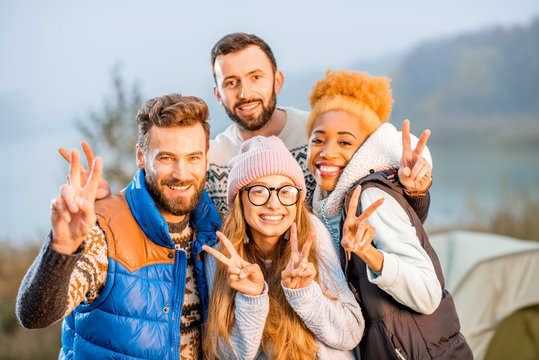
341, 186, 384, 271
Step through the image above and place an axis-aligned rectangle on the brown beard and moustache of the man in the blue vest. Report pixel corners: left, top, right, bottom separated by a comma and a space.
145, 171, 206, 216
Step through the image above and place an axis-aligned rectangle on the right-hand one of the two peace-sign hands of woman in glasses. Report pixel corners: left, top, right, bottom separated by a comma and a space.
281, 222, 316, 289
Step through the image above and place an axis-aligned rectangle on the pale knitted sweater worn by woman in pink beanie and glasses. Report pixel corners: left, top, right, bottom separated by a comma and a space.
205, 215, 365, 360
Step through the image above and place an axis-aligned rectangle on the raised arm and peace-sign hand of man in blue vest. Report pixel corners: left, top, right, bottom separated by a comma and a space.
17, 150, 106, 327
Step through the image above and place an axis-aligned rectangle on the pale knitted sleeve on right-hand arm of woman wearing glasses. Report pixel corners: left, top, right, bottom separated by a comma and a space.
283, 216, 365, 350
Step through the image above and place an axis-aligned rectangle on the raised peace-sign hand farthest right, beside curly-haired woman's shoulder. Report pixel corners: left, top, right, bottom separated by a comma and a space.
399, 120, 432, 193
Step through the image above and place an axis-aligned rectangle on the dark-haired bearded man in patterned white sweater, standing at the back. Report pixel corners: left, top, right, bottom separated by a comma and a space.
206, 33, 315, 212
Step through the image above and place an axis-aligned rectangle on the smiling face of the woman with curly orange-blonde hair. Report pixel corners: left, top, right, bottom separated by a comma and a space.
307, 111, 369, 192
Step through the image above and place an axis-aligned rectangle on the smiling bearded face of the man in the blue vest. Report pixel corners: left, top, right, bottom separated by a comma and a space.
137, 123, 207, 223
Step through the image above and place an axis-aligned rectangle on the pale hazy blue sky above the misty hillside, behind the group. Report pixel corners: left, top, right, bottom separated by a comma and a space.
0, 0, 539, 241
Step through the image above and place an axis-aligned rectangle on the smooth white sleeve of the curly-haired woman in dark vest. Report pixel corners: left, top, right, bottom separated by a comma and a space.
360, 188, 442, 314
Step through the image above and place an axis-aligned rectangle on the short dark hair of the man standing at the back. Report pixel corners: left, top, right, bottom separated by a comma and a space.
211, 33, 277, 80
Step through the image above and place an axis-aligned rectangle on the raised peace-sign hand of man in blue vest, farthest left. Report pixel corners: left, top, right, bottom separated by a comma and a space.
51, 150, 102, 254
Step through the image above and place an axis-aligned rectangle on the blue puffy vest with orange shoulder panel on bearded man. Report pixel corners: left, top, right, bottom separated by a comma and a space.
59, 170, 222, 360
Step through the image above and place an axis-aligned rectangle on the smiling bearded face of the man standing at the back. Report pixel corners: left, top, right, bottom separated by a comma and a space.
213, 45, 283, 131
